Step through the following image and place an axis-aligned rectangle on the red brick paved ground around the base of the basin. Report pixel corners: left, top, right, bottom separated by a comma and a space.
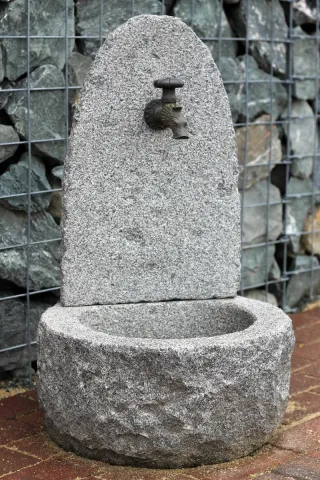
0, 308, 320, 480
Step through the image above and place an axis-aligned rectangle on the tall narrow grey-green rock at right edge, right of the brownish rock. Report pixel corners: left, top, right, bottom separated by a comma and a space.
282, 100, 317, 178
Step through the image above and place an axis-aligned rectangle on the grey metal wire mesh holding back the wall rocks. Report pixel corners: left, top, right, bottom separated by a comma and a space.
0, 0, 320, 382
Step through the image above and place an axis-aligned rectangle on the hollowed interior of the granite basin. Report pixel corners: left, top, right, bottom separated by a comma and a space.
80, 299, 255, 339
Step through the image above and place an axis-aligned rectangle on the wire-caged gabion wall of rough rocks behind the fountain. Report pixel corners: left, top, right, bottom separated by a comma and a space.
0, 0, 320, 378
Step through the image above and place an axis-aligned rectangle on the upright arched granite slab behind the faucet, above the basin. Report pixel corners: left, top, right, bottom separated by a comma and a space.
61, 15, 240, 306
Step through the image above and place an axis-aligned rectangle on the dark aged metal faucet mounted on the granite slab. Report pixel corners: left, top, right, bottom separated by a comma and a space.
144, 78, 189, 139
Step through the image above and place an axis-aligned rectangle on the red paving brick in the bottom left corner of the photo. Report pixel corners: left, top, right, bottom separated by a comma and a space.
5, 455, 97, 480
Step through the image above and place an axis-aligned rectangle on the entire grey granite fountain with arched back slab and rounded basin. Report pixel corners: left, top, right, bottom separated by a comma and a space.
38, 15, 294, 468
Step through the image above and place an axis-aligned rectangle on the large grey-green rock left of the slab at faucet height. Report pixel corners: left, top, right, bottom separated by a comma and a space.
5, 65, 66, 163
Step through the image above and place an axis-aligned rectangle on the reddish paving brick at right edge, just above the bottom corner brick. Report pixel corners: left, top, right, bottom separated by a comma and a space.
271, 417, 320, 453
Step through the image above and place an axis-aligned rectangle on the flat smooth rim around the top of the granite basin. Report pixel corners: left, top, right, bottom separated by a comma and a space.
41, 297, 291, 350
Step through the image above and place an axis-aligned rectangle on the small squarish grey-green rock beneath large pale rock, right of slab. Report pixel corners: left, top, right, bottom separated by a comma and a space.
241, 245, 275, 288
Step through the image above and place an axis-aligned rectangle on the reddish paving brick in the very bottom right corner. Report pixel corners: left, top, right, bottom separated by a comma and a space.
272, 456, 320, 480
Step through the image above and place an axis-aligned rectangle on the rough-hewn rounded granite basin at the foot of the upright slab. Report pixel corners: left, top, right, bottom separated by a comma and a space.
38, 297, 294, 468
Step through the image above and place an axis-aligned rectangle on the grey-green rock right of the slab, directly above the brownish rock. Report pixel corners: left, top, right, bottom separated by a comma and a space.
239, 55, 288, 121
